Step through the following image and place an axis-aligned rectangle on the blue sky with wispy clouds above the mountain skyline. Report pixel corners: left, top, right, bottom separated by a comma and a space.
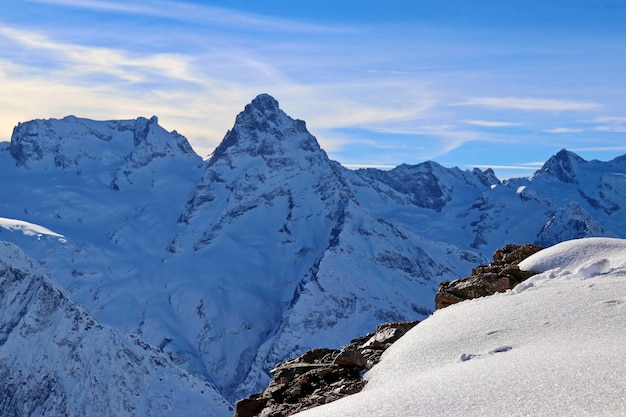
0, 0, 626, 178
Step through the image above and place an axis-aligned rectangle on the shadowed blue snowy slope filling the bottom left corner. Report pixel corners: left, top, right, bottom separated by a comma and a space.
0, 242, 231, 417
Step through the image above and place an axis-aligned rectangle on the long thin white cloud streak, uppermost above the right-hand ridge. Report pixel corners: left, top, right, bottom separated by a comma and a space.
456, 97, 602, 112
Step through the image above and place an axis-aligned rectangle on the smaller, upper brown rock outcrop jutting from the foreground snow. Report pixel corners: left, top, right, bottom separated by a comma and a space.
435, 244, 542, 309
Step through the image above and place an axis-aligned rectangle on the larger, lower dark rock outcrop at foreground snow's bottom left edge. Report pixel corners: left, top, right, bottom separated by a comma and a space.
235, 321, 418, 417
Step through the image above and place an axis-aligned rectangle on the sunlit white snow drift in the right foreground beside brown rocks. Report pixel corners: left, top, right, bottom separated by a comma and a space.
298, 238, 626, 417
